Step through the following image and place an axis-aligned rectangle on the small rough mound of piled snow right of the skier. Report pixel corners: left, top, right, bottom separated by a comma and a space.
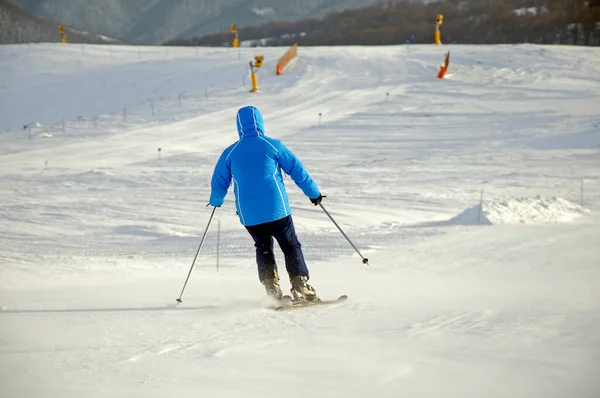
447, 196, 587, 225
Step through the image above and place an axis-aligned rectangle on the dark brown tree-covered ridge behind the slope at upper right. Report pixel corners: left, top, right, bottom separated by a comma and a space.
167, 0, 600, 46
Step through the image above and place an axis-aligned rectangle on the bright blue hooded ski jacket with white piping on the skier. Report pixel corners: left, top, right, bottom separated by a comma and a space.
209, 106, 320, 226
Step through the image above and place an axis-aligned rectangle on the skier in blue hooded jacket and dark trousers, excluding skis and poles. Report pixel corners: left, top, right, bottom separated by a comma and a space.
209, 106, 324, 301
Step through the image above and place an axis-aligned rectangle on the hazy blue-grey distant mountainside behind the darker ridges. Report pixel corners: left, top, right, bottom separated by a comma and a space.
14, 0, 386, 44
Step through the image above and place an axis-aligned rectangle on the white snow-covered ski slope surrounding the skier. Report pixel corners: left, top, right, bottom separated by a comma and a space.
0, 44, 600, 398
